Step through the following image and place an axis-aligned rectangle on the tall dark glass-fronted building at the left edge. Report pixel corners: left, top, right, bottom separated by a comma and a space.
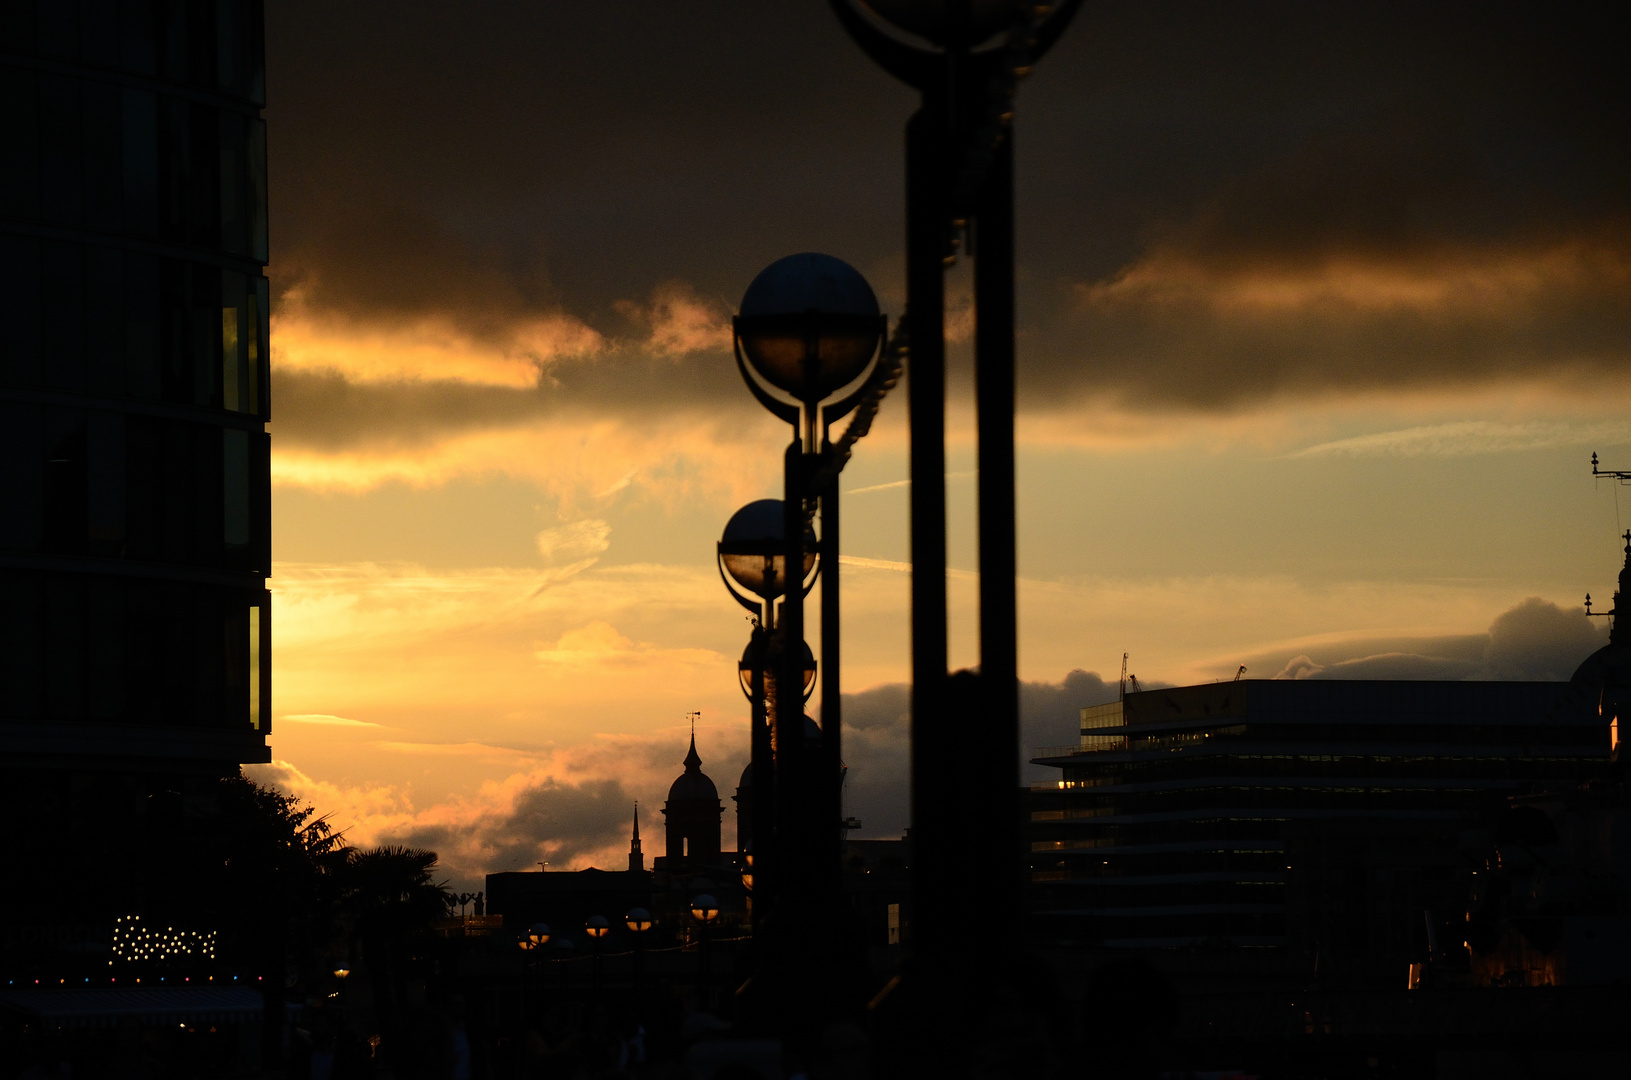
0, 0, 271, 779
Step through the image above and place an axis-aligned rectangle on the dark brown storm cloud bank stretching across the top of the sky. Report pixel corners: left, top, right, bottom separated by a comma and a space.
267, 0, 1631, 440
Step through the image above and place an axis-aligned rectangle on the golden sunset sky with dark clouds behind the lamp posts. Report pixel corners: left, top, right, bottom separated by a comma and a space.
251, 0, 1631, 887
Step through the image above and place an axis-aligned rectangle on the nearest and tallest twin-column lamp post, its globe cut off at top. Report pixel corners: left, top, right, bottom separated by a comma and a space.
829, 0, 1081, 969
